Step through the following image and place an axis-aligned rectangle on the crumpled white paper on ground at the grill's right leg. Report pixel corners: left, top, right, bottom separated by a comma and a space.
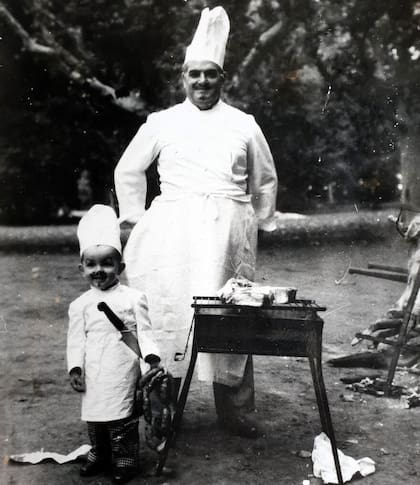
312, 433, 375, 483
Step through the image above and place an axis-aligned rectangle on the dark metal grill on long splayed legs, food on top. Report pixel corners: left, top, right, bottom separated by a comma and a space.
156, 296, 343, 484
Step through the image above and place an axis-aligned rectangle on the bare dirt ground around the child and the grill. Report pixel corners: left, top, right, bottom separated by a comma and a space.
0, 233, 420, 485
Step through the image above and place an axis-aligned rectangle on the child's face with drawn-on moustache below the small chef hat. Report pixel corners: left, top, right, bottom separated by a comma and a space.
79, 245, 125, 290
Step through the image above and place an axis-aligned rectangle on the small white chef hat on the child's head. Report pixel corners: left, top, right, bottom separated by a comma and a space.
77, 204, 121, 256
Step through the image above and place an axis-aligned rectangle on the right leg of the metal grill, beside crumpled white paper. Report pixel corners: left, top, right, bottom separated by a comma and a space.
308, 351, 344, 485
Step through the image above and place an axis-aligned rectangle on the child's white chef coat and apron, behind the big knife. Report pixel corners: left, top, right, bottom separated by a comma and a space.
67, 284, 159, 421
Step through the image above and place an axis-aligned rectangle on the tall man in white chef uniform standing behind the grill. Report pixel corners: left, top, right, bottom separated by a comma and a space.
115, 7, 277, 438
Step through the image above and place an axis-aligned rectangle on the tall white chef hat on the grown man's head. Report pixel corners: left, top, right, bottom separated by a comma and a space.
184, 7, 230, 69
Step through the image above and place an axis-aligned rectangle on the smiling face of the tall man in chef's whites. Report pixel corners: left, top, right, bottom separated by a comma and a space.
182, 61, 224, 110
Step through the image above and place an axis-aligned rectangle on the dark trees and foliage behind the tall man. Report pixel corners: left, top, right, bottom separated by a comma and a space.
0, 0, 420, 224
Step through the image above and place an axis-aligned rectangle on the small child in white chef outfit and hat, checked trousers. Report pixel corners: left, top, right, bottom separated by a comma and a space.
67, 205, 160, 483
